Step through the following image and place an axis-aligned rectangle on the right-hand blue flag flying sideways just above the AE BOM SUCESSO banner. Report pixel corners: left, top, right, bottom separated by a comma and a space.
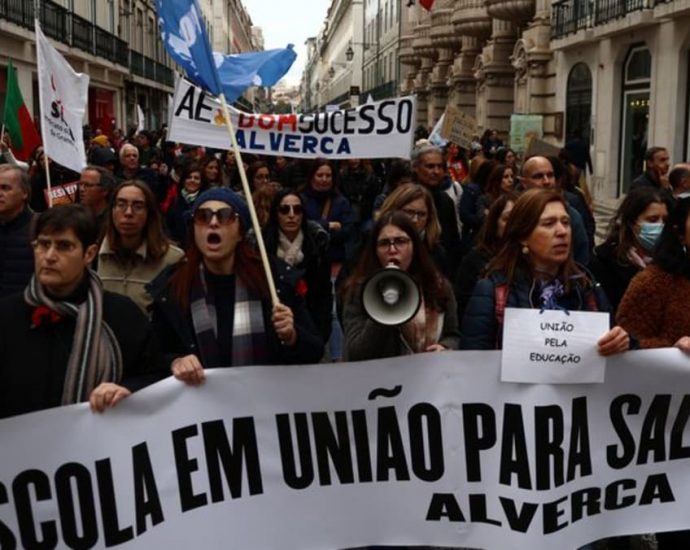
216, 44, 297, 101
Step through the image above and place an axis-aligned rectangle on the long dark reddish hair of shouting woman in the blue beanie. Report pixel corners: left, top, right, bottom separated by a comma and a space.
170, 203, 269, 310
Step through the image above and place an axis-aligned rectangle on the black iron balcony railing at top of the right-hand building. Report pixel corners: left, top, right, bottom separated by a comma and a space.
551, 0, 668, 39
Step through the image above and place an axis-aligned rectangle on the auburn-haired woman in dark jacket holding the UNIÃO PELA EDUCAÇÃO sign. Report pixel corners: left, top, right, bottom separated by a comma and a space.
460, 189, 630, 355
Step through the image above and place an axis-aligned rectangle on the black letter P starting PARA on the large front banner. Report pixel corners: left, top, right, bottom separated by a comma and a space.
462, 403, 496, 481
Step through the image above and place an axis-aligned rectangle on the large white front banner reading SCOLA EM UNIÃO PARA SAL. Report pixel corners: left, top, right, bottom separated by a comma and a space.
0, 349, 690, 550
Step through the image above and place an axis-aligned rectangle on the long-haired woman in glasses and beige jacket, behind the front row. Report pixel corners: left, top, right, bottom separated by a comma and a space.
98, 180, 184, 313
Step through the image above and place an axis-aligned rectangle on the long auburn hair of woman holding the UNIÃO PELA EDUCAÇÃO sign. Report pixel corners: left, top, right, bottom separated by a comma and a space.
487, 189, 583, 290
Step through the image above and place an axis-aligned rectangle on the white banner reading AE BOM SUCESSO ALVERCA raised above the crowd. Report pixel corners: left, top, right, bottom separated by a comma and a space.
168, 78, 416, 159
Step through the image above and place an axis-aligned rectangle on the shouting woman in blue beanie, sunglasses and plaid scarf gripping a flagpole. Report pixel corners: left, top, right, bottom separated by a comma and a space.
151, 188, 323, 385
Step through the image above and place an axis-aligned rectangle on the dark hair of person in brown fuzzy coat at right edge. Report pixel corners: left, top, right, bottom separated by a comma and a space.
653, 198, 690, 278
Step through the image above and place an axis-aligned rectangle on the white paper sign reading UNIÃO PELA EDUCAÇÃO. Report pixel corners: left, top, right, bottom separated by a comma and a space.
501, 307, 609, 384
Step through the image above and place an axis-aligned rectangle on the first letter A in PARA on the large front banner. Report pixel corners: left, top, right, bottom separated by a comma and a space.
499, 403, 532, 489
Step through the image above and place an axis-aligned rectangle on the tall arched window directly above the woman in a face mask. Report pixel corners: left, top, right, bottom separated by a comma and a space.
618, 45, 654, 193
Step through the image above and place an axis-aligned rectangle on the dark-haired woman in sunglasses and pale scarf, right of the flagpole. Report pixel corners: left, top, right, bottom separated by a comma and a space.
263, 189, 333, 342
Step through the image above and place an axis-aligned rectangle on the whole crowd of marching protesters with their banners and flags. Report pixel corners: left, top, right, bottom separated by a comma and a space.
0, 0, 690, 550
